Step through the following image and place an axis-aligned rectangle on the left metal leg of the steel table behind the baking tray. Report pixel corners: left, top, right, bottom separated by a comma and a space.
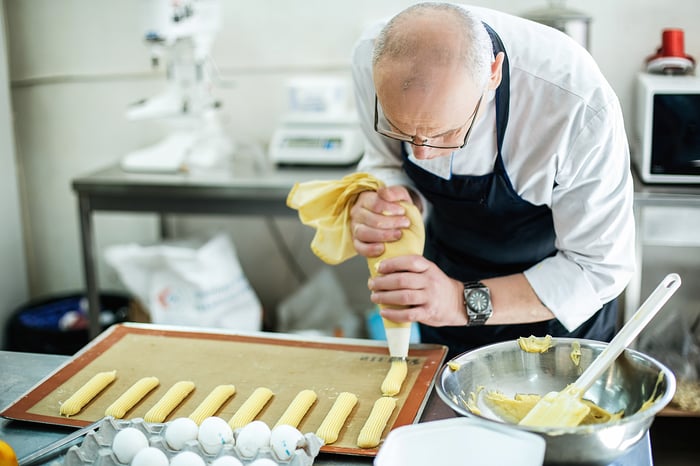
78, 196, 102, 340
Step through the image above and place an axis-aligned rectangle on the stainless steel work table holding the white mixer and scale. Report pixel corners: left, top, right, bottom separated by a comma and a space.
73, 159, 352, 338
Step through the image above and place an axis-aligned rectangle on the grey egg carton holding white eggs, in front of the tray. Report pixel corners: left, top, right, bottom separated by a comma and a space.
63, 417, 323, 466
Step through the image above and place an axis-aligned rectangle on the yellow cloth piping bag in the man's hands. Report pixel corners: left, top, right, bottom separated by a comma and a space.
287, 173, 425, 359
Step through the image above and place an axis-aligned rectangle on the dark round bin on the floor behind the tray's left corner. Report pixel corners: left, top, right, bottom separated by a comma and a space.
5, 293, 131, 355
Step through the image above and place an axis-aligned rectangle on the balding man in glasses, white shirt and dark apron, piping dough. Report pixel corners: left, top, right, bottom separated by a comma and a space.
351, 3, 634, 355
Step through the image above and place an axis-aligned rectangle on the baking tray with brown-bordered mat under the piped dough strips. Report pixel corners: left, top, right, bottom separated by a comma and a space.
0, 323, 447, 456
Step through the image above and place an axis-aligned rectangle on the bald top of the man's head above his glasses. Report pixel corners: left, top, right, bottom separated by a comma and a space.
373, 3, 493, 88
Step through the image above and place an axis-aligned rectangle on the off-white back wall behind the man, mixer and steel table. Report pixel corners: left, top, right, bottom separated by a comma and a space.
4, 0, 700, 332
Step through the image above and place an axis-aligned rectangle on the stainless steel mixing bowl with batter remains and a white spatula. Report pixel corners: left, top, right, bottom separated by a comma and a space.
436, 338, 676, 466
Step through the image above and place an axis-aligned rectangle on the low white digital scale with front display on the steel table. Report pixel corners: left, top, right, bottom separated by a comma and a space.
269, 117, 364, 166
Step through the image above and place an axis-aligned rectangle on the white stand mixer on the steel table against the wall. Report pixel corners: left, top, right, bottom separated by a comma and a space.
121, 0, 234, 172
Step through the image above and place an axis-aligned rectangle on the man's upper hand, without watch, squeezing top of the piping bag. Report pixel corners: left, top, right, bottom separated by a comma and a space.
350, 186, 413, 257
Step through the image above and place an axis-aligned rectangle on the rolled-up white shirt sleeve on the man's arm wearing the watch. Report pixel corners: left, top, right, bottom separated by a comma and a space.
525, 99, 635, 331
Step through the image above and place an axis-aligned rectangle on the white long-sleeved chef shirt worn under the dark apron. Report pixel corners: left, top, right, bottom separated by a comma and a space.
353, 6, 635, 331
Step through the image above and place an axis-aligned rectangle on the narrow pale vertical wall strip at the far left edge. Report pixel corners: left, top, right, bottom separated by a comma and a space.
0, 0, 28, 348
